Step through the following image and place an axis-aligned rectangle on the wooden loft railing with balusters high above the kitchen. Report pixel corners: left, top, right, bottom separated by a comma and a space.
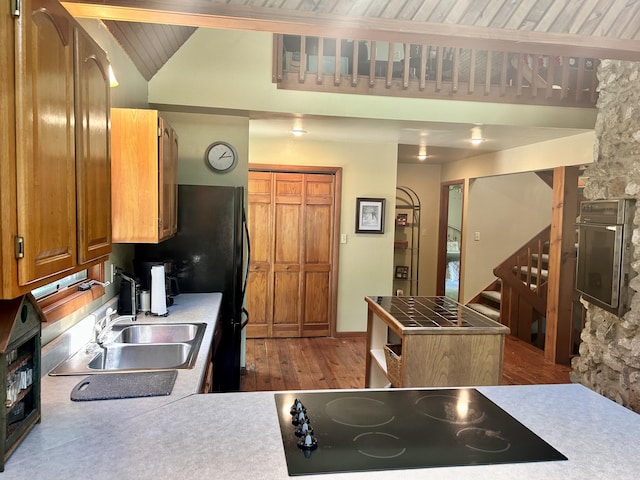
273, 34, 599, 107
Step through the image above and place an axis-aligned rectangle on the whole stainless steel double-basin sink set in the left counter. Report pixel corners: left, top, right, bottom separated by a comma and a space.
50, 323, 207, 375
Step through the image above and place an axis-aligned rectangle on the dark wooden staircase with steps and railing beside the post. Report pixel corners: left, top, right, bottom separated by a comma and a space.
468, 226, 551, 348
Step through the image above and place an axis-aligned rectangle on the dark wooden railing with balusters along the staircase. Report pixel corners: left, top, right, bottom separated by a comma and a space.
493, 226, 551, 316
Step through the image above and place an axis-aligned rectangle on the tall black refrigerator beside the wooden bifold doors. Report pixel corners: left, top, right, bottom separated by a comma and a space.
134, 185, 250, 392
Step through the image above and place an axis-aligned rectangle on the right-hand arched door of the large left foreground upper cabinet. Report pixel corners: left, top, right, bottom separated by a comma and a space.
75, 28, 111, 264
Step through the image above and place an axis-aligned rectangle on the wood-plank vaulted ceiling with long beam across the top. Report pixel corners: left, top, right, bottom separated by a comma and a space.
61, 0, 640, 80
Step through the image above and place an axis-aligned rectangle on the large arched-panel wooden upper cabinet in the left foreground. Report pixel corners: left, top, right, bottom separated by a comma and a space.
0, 0, 111, 298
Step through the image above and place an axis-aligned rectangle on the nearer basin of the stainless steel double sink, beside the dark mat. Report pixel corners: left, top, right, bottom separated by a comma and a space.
88, 343, 194, 370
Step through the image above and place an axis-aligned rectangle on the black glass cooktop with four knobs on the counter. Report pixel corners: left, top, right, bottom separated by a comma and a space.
275, 388, 567, 475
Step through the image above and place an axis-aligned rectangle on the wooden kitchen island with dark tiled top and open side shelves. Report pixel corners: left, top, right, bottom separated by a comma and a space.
365, 296, 509, 388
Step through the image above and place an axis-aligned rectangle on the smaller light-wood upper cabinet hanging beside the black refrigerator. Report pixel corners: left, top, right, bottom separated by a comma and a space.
111, 108, 178, 243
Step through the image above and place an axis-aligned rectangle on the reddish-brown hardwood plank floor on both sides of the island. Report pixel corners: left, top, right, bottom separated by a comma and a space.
240, 336, 571, 392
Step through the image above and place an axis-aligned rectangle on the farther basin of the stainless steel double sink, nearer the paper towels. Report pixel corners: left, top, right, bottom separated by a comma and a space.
113, 323, 207, 344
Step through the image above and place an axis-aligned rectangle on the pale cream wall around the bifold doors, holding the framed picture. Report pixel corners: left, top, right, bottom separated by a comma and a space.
249, 137, 397, 332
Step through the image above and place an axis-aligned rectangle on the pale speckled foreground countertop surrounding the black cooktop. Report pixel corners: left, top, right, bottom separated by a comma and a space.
5, 297, 640, 480
